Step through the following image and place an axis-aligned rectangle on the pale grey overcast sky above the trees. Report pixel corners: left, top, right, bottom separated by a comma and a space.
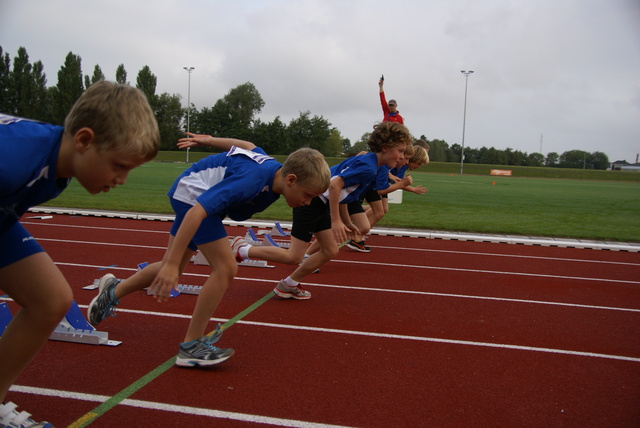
0, 0, 640, 162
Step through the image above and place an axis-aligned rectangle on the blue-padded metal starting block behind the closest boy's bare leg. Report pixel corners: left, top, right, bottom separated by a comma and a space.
0, 300, 122, 346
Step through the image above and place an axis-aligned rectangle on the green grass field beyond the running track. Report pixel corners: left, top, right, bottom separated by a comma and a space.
46, 162, 640, 242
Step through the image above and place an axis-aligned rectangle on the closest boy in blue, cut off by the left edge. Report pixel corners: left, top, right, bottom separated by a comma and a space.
0, 81, 160, 427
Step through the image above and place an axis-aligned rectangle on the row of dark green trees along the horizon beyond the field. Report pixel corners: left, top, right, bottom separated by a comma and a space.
0, 46, 609, 169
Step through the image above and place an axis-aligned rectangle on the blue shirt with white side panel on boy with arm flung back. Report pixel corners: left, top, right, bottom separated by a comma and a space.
168, 146, 282, 221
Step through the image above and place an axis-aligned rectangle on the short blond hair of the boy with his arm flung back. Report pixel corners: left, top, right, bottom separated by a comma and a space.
282, 147, 331, 193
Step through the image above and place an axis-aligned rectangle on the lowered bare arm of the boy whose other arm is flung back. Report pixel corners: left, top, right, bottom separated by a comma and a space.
151, 204, 207, 302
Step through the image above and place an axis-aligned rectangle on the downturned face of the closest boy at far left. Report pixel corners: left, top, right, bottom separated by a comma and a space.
74, 145, 145, 195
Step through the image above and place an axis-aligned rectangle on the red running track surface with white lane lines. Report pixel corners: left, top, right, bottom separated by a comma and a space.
5, 214, 640, 427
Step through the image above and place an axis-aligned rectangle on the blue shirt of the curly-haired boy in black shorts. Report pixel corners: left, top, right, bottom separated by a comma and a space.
320, 153, 380, 204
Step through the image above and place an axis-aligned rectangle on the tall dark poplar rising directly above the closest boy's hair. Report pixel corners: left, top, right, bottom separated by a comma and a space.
51, 52, 84, 125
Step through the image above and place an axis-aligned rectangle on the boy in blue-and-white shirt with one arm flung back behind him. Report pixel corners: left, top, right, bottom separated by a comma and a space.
87, 133, 330, 367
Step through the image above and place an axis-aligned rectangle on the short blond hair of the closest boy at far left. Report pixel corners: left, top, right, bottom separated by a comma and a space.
64, 80, 160, 160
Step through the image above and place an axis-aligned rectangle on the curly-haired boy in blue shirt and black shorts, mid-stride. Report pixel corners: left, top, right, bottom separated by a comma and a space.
232, 122, 413, 300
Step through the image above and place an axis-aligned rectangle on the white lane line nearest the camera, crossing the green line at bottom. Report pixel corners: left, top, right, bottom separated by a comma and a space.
9, 385, 356, 428
